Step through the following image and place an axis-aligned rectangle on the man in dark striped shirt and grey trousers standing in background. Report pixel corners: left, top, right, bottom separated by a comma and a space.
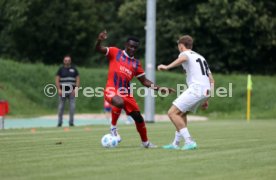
56, 55, 80, 127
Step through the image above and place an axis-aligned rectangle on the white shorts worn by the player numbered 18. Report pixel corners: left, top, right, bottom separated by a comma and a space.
173, 85, 210, 113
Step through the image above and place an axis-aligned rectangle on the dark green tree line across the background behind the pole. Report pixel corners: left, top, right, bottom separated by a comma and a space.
0, 0, 276, 74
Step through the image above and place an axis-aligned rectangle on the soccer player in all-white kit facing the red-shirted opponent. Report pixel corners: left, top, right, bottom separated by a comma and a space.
158, 35, 214, 150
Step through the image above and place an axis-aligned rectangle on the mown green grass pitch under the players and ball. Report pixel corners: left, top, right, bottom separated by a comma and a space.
0, 120, 276, 180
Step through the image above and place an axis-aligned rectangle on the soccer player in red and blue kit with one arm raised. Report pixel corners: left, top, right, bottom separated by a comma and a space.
96, 31, 175, 148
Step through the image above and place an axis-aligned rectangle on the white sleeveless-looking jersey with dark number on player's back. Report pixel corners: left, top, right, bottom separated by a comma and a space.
179, 50, 211, 89
